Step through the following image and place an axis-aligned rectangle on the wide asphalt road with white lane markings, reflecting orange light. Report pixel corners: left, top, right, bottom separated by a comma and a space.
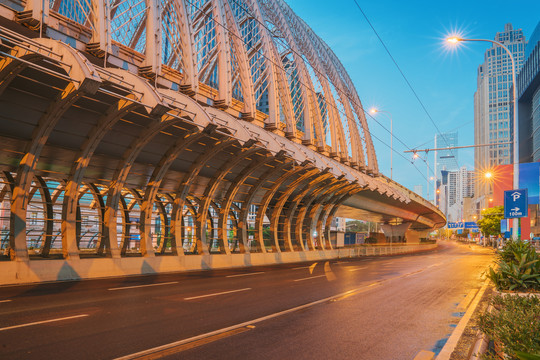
0, 242, 493, 360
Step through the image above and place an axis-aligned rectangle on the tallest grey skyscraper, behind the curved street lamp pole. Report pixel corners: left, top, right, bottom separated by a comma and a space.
474, 24, 527, 207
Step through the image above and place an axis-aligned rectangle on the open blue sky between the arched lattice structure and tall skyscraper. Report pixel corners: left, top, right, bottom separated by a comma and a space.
286, 0, 540, 198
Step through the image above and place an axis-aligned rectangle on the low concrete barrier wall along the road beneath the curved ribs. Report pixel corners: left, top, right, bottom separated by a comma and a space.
0, 244, 437, 285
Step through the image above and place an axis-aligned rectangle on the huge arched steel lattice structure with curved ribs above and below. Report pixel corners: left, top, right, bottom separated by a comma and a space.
0, 0, 440, 261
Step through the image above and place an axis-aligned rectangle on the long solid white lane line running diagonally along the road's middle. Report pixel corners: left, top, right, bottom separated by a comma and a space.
114, 284, 378, 360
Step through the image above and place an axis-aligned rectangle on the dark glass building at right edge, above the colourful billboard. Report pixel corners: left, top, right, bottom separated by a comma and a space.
517, 22, 540, 162
